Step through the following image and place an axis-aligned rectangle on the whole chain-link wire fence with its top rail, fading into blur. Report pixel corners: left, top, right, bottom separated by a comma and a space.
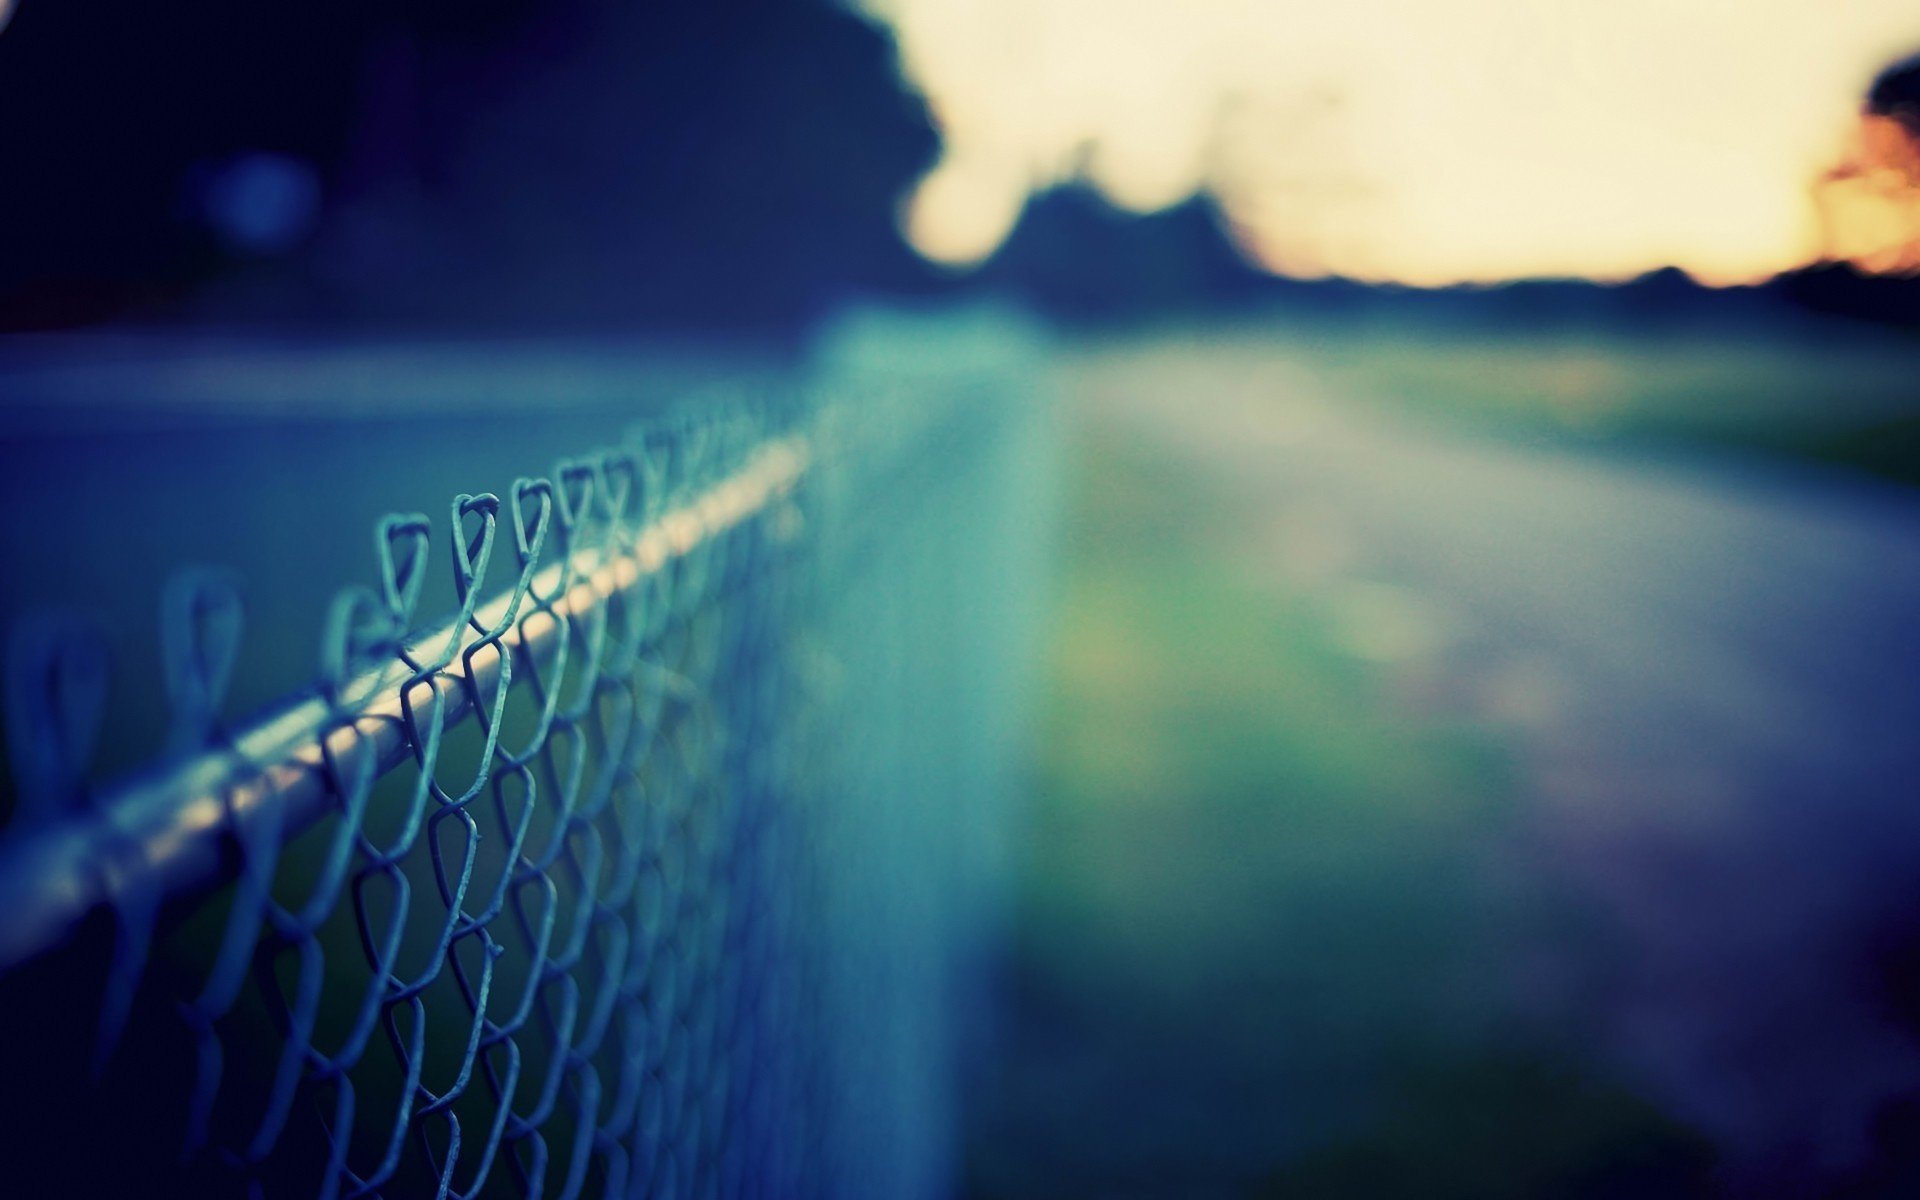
0, 351, 1044, 1196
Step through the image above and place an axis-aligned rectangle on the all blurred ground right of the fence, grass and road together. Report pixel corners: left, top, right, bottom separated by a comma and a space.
979, 328, 1920, 1196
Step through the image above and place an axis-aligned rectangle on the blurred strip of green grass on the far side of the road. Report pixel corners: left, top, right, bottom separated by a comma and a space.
1075, 323, 1920, 484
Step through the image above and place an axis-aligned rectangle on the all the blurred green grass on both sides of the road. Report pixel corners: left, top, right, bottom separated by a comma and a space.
972, 320, 1920, 1200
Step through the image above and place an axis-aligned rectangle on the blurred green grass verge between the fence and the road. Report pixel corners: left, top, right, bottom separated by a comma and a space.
972, 414, 1705, 1198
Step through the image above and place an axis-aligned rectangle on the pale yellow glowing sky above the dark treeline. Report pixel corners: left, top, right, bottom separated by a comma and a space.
864, 0, 1920, 284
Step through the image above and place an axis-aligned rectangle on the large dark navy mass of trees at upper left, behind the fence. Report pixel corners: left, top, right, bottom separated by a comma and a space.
0, 0, 937, 328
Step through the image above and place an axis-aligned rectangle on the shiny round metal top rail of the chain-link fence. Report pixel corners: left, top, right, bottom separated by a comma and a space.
0, 434, 814, 972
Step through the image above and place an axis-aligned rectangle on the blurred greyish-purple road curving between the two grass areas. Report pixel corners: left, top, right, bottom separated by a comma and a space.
1068, 355, 1920, 1171
